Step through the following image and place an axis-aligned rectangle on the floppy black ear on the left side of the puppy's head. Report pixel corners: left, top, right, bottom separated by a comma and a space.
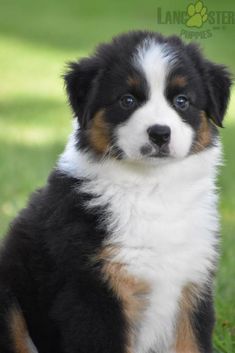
64, 58, 100, 128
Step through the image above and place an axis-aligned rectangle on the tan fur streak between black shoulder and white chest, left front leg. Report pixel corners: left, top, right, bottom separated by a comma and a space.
98, 246, 150, 353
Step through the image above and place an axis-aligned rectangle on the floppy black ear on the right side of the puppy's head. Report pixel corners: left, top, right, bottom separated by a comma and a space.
205, 61, 232, 127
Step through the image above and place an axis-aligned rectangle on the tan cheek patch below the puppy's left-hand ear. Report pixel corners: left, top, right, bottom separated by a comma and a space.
88, 109, 110, 154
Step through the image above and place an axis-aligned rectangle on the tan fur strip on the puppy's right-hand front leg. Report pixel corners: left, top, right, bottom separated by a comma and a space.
175, 285, 200, 353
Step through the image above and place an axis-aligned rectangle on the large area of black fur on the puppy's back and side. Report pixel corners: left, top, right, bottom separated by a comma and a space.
0, 172, 125, 353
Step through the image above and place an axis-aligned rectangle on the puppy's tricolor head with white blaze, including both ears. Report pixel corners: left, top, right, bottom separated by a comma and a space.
65, 32, 231, 160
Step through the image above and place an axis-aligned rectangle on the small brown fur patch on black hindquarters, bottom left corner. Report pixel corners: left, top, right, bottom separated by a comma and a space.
9, 308, 30, 353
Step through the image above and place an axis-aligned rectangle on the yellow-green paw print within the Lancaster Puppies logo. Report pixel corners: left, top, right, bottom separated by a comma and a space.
186, 1, 208, 28
